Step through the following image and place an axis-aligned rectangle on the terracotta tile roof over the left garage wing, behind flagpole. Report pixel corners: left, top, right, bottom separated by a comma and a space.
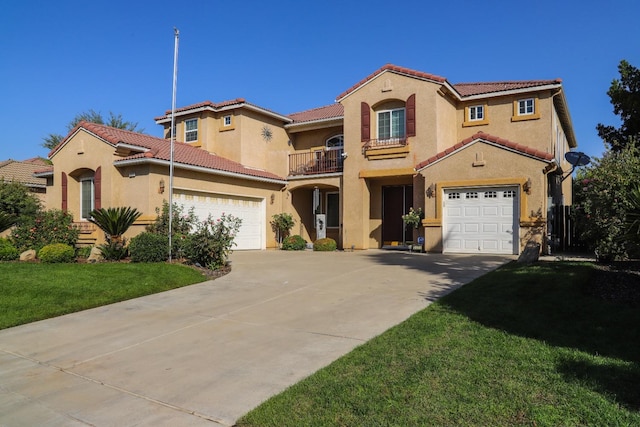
49, 121, 285, 183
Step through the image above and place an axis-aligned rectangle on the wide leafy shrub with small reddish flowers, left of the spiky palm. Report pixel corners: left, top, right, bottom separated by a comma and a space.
11, 209, 80, 252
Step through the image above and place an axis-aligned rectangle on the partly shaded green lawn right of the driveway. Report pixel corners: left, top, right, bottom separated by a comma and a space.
238, 262, 640, 427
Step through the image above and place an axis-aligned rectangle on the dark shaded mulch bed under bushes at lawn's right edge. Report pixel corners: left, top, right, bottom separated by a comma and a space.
585, 261, 640, 307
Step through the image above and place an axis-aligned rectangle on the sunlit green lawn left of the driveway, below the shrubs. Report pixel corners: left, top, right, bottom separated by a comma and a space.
0, 262, 207, 329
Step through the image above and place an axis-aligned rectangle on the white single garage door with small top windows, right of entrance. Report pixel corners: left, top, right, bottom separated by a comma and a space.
443, 187, 519, 254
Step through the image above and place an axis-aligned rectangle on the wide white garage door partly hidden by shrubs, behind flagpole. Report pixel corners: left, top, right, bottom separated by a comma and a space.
173, 190, 265, 250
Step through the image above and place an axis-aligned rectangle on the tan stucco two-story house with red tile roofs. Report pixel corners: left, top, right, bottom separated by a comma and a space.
41, 65, 577, 254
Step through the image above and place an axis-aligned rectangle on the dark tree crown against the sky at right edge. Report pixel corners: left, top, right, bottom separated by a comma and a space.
596, 60, 640, 152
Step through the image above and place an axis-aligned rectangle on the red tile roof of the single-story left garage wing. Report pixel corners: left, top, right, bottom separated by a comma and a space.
54, 122, 284, 181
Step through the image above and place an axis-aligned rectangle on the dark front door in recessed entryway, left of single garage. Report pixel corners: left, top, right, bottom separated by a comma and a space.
382, 185, 413, 245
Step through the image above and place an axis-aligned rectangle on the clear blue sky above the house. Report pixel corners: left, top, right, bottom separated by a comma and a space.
0, 0, 640, 160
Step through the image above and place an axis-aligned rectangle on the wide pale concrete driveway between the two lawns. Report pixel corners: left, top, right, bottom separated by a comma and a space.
0, 250, 513, 426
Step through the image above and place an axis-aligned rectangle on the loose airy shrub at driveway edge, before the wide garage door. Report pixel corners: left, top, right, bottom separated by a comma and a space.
184, 214, 242, 270
